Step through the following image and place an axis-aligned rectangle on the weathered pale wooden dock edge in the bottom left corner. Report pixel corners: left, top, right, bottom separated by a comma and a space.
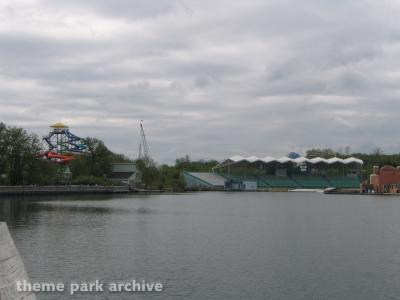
0, 222, 36, 300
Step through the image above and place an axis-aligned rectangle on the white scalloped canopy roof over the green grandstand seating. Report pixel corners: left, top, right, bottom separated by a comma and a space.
213, 155, 364, 169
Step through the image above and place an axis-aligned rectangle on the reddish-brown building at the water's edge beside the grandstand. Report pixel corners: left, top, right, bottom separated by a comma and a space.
369, 166, 400, 193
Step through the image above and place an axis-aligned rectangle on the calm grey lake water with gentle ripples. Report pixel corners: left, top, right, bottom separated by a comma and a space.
0, 192, 400, 300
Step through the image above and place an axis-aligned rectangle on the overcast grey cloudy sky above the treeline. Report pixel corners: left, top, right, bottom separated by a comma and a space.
0, 0, 400, 162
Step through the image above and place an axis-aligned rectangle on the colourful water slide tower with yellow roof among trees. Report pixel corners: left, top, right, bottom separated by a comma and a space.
41, 123, 87, 179
